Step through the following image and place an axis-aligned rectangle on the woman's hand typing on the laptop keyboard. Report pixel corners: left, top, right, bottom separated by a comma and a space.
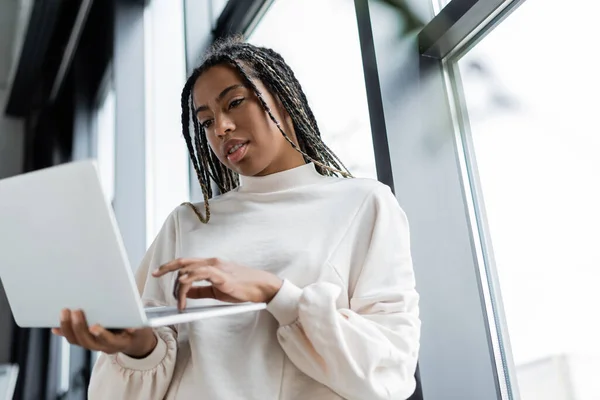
152, 258, 283, 310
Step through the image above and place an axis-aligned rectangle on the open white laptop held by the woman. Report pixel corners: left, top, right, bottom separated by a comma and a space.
0, 161, 265, 329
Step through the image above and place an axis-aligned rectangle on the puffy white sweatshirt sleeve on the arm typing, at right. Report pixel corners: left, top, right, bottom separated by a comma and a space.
268, 186, 421, 400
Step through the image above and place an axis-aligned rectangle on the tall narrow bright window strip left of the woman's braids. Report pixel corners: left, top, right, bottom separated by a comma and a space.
144, 0, 190, 244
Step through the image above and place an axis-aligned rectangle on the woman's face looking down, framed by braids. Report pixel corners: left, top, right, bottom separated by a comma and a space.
193, 65, 304, 176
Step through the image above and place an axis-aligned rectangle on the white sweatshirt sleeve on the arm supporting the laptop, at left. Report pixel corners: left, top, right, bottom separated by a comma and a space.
88, 211, 177, 400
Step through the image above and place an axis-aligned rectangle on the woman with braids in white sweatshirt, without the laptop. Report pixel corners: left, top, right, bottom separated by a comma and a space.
55, 39, 420, 400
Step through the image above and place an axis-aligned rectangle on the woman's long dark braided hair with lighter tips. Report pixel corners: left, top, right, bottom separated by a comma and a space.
181, 36, 351, 223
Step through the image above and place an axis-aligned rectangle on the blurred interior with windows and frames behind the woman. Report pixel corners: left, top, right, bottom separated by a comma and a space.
0, 0, 600, 400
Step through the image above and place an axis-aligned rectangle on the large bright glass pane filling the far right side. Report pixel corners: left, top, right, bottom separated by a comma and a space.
458, 0, 600, 400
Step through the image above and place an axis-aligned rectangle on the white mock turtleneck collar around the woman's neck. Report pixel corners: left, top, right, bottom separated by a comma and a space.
238, 163, 323, 193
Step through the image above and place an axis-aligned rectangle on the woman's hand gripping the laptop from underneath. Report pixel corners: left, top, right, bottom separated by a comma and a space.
52, 309, 157, 358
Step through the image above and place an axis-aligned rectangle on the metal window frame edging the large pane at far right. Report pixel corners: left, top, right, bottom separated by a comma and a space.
418, 0, 525, 400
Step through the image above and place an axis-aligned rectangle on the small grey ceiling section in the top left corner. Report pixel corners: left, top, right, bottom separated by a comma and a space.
0, 0, 34, 90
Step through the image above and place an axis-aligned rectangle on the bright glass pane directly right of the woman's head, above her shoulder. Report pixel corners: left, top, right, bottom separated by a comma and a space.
248, 0, 377, 178
